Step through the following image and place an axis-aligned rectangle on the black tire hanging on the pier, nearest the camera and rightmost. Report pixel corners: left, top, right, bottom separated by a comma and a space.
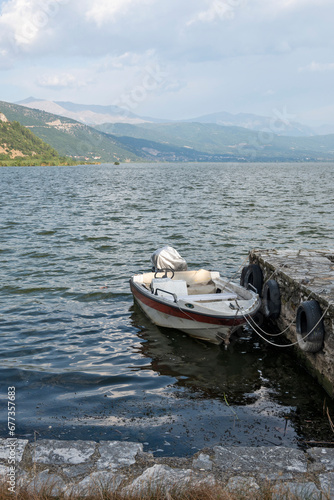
296, 300, 325, 352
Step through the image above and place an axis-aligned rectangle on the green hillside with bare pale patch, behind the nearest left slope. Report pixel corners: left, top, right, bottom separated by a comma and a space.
0, 101, 142, 162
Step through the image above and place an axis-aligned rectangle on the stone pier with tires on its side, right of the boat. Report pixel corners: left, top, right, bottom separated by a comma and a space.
249, 249, 334, 397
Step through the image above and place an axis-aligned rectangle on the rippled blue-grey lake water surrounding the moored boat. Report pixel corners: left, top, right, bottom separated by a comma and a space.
0, 163, 334, 455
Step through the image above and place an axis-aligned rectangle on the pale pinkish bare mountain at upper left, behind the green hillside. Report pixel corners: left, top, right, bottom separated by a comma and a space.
15, 97, 155, 125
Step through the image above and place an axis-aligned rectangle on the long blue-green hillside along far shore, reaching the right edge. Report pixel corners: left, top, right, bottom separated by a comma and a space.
96, 122, 334, 161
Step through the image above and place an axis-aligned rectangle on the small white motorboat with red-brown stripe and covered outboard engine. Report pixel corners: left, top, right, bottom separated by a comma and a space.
130, 246, 261, 345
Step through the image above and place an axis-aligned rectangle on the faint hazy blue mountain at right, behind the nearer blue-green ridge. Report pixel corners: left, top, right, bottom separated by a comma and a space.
185, 112, 315, 137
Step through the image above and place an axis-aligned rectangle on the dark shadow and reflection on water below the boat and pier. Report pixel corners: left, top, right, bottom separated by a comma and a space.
131, 304, 334, 448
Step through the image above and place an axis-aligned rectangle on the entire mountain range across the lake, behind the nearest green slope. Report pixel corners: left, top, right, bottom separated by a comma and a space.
0, 98, 334, 163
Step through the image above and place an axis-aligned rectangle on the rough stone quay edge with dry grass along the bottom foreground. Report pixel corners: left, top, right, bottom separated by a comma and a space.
0, 439, 334, 500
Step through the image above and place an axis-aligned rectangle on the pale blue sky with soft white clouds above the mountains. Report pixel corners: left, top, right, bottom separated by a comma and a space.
0, 0, 334, 126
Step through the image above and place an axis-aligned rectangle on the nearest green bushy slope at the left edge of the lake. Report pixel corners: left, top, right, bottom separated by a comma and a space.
0, 115, 73, 166
